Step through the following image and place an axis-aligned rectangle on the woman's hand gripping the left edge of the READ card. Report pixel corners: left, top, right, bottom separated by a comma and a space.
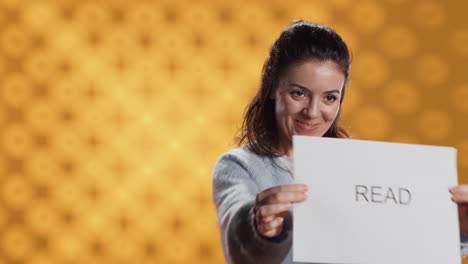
253, 184, 308, 237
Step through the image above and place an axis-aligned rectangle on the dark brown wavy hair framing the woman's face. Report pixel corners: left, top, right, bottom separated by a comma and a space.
235, 20, 351, 157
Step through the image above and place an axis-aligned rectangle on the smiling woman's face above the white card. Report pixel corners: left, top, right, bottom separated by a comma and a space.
272, 60, 345, 155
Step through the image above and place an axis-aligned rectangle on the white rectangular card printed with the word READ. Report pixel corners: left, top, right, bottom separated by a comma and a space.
293, 136, 461, 264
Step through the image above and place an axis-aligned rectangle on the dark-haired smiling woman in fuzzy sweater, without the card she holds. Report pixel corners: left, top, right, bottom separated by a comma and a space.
213, 21, 468, 263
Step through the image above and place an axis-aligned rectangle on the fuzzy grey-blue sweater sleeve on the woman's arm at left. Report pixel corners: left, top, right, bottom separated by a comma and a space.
213, 153, 292, 264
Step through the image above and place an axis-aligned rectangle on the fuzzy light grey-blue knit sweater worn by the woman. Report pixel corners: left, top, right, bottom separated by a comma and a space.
213, 146, 468, 264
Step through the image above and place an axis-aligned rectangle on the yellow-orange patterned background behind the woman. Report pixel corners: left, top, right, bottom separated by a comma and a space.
0, 0, 468, 264
